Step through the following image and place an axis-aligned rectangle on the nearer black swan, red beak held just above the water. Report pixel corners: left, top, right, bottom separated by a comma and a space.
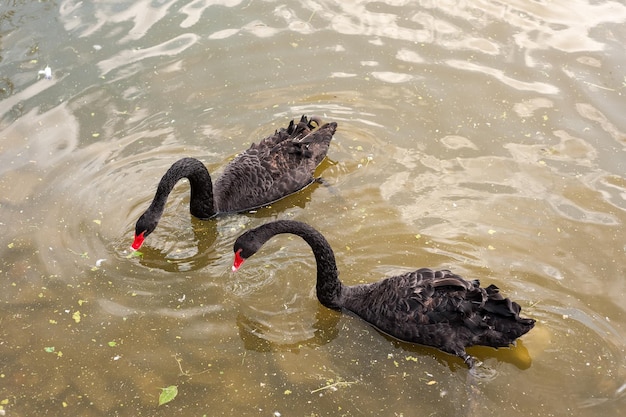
232, 220, 535, 368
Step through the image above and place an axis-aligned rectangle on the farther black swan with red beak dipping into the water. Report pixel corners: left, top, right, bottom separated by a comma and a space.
131, 116, 337, 250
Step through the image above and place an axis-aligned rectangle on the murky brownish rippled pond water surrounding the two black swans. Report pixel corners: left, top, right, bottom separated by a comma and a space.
0, 0, 626, 416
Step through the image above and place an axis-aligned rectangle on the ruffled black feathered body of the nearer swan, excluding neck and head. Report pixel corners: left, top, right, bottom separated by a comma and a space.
343, 268, 534, 361
